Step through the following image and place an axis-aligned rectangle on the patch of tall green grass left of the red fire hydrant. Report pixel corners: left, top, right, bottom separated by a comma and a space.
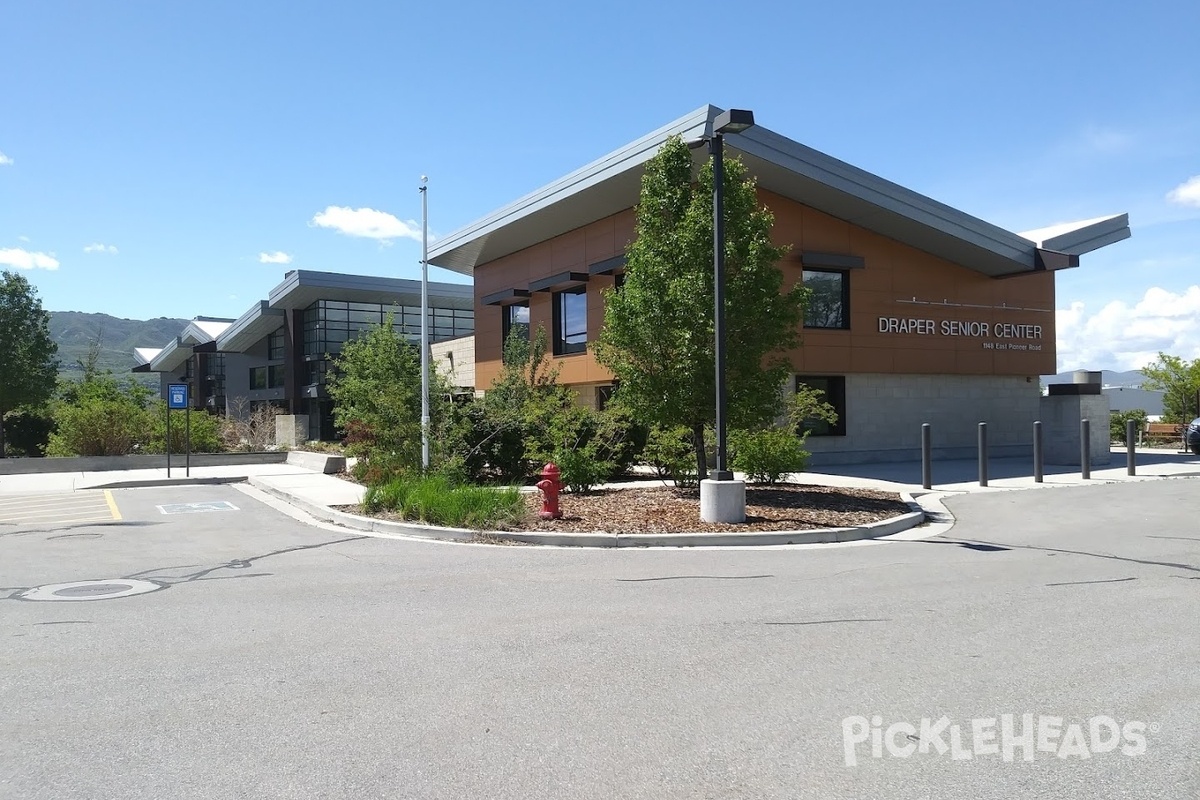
362, 475, 524, 529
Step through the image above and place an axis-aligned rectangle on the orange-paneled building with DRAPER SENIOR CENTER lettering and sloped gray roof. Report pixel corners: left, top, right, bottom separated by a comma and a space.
430, 106, 1129, 463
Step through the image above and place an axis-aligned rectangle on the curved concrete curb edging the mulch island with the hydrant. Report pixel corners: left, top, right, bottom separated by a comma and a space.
248, 477, 925, 547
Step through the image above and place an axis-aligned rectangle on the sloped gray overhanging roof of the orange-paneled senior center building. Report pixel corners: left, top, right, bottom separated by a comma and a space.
430, 106, 1129, 277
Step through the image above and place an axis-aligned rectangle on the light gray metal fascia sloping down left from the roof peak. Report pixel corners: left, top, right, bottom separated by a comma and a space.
430, 106, 721, 275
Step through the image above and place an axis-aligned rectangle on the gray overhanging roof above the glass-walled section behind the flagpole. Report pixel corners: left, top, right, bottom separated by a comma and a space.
268, 270, 475, 309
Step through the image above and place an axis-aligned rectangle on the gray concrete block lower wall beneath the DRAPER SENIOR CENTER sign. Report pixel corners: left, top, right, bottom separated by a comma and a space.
806, 374, 1041, 467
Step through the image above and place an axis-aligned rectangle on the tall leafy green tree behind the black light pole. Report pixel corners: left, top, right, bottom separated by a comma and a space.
595, 137, 808, 477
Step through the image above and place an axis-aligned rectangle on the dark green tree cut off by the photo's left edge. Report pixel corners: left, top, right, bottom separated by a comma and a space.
0, 271, 59, 458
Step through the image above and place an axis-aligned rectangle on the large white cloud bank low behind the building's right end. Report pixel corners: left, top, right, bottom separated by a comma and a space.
1057, 285, 1200, 372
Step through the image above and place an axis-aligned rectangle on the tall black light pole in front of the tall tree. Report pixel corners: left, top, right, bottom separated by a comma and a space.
708, 108, 754, 481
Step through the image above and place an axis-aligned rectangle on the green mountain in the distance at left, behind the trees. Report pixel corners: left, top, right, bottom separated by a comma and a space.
50, 311, 187, 377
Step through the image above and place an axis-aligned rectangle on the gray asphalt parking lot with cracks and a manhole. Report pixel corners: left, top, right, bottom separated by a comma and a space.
0, 480, 1200, 800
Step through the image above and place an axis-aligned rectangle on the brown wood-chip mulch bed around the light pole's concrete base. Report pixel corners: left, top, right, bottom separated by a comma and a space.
516, 483, 910, 534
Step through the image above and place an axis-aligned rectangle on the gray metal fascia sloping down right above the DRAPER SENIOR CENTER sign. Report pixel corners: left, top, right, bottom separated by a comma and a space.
725, 126, 1036, 270
